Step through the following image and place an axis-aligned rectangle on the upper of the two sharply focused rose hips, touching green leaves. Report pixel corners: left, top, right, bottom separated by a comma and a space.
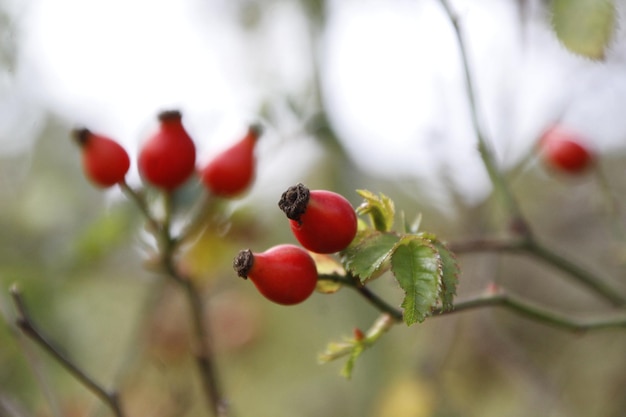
278, 184, 357, 253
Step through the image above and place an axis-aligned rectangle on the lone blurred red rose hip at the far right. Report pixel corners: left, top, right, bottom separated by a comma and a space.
539, 126, 594, 174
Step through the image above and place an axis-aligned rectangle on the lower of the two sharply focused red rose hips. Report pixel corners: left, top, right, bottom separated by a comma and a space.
233, 245, 317, 305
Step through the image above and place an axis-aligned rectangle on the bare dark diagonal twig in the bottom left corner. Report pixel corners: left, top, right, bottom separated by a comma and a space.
10, 285, 124, 417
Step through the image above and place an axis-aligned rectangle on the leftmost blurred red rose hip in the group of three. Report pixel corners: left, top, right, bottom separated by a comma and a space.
72, 128, 130, 188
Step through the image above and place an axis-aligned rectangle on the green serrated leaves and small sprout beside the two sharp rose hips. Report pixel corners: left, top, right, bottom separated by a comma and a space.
316, 190, 459, 378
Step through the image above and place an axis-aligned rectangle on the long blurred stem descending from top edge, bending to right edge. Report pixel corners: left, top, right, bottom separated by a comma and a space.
439, 0, 626, 306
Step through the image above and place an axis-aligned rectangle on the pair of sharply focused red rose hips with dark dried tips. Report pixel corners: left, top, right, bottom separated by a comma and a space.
233, 184, 357, 305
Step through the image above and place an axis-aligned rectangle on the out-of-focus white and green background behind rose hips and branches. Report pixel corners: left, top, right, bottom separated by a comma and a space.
0, 0, 626, 417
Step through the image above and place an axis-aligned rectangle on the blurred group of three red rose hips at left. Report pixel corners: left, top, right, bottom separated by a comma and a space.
73, 110, 262, 198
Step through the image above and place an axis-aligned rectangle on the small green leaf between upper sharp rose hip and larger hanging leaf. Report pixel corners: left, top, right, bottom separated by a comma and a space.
342, 230, 400, 282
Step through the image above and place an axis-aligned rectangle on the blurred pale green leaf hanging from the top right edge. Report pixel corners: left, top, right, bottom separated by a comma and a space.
551, 0, 617, 60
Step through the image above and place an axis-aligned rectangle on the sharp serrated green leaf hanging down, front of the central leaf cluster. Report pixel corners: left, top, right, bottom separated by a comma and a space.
391, 236, 442, 325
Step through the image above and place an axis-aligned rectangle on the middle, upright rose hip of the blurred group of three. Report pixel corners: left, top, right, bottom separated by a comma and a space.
138, 110, 196, 191
